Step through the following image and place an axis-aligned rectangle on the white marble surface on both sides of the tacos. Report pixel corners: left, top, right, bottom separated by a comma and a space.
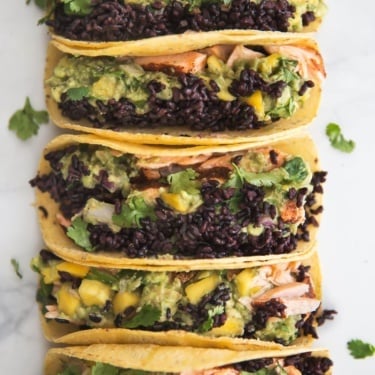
0, 0, 375, 375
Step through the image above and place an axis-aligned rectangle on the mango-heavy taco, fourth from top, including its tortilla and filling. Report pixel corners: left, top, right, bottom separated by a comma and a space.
32, 250, 321, 350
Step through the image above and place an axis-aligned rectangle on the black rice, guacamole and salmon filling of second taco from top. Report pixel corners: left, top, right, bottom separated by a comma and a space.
46, 45, 325, 132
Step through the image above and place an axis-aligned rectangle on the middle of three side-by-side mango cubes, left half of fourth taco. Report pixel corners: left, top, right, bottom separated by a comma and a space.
78, 279, 112, 307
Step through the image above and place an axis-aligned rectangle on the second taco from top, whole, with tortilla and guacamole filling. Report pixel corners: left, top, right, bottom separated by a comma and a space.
45, 33, 325, 145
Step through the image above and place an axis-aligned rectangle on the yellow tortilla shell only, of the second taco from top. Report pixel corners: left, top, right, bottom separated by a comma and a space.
45, 31, 325, 145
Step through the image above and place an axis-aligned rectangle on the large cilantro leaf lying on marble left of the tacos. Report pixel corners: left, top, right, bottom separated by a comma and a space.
8, 97, 48, 141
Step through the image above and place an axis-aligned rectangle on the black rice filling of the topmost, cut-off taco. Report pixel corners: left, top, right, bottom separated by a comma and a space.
46, 0, 326, 41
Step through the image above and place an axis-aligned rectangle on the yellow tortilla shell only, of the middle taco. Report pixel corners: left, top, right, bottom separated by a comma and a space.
35, 134, 321, 270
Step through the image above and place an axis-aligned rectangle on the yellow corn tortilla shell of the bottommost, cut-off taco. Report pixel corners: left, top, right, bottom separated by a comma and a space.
44, 344, 332, 375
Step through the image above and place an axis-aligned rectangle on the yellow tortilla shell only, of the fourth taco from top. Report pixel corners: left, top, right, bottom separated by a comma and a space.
40, 248, 322, 351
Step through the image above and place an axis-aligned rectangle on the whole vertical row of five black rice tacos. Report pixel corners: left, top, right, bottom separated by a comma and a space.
30, 0, 332, 375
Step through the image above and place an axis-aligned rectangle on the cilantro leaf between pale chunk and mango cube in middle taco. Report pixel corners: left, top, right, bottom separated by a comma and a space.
112, 195, 156, 228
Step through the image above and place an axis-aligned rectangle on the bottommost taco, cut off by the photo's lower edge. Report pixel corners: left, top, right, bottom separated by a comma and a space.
45, 344, 333, 375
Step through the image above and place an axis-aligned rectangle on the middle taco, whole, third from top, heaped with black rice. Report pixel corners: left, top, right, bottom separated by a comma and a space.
30, 135, 326, 269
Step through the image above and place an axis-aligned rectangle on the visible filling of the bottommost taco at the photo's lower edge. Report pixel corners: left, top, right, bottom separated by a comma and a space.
49, 352, 333, 375
